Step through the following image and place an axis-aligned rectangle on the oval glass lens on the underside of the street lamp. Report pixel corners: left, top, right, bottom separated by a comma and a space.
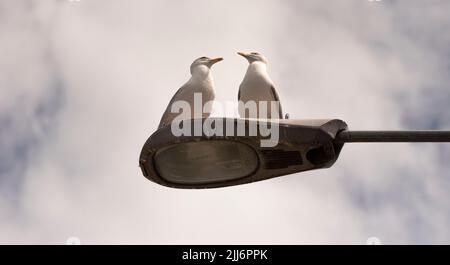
154, 140, 258, 184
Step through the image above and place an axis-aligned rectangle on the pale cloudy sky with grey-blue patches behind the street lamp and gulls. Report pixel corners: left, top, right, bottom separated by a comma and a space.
0, 0, 450, 244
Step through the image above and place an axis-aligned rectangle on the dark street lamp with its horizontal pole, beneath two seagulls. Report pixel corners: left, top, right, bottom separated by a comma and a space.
139, 118, 450, 189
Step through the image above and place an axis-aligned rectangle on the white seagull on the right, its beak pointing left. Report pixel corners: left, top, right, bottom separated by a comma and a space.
238, 52, 283, 119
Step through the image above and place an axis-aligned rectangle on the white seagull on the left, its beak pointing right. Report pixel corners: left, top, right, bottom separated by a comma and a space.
158, 57, 223, 128
